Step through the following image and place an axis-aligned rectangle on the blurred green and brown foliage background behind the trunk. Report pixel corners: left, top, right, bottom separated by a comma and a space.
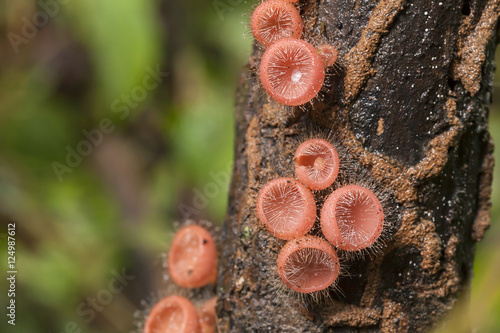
0, 0, 500, 333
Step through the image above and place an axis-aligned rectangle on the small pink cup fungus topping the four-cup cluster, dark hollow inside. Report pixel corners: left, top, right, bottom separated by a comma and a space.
295, 139, 339, 190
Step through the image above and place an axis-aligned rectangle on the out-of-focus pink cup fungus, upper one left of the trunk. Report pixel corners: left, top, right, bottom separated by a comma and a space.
168, 225, 217, 288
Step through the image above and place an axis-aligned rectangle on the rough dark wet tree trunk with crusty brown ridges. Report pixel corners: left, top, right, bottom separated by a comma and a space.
217, 0, 500, 332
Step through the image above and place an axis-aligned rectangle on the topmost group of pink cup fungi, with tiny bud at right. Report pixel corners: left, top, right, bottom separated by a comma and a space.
250, 0, 337, 106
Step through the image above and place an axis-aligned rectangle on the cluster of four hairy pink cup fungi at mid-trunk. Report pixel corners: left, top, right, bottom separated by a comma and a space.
256, 139, 384, 295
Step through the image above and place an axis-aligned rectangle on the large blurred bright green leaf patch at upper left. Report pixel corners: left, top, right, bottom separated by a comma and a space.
62, 0, 160, 106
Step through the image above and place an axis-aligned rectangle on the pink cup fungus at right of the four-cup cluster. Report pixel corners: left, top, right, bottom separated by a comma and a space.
321, 185, 384, 251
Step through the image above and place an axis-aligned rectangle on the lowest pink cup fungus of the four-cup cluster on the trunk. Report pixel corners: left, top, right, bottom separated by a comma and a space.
278, 236, 340, 293
